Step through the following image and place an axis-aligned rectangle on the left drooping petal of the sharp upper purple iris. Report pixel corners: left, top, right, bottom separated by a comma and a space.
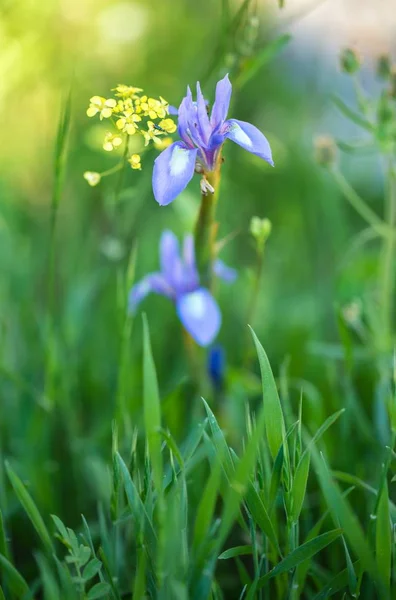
153, 142, 198, 206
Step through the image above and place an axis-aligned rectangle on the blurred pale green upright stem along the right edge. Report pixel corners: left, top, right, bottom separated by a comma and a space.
380, 158, 396, 351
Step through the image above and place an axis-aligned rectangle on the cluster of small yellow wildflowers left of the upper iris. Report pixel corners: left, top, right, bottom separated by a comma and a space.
87, 84, 176, 172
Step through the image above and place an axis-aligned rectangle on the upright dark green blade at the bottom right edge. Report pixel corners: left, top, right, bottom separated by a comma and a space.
375, 481, 392, 592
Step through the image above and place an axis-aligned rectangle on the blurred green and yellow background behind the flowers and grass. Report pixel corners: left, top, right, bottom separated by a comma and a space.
0, 0, 396, 564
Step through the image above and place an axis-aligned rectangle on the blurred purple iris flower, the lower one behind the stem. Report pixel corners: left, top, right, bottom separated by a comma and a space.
129, 231, 236, 346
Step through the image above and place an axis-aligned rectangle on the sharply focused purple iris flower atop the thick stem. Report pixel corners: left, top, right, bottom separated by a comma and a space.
153, 75, 274, 206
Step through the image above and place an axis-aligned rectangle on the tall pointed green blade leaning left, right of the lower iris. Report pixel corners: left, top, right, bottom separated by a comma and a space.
249, 326, 286, 460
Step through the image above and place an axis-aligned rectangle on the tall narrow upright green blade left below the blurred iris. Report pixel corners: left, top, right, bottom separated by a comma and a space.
143, 315, 163, 493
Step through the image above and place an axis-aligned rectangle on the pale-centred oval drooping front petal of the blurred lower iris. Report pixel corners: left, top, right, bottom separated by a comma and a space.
176, 288, 221, 346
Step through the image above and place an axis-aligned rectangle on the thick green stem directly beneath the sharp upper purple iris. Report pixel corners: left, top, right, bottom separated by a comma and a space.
195, 154, 222, 287
